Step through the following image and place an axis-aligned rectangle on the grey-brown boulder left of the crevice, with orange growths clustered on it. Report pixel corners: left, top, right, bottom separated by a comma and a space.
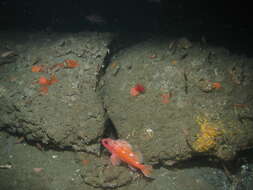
0, 33, 112, 153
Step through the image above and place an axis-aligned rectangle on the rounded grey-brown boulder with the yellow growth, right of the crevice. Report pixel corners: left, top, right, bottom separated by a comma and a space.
101, 39, 253, 165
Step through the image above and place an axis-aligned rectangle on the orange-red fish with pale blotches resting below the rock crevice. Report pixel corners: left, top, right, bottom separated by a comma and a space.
101, 138, 152, 177
